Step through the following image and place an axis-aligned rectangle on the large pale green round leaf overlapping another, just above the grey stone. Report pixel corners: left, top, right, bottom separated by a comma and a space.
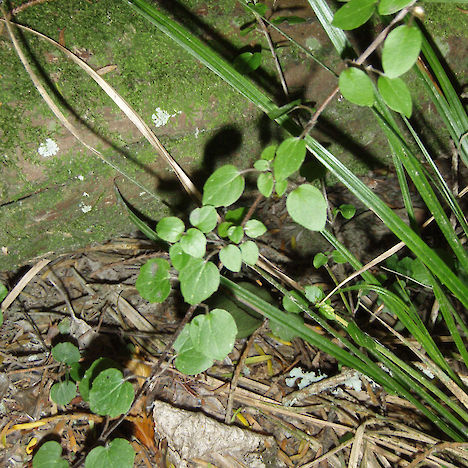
189, 309, 237, 361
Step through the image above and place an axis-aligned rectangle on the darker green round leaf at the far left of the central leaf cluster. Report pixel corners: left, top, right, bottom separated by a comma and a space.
135, 258, 171, 302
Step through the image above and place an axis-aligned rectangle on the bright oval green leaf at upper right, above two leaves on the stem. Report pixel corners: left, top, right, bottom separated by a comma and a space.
382, 25, 422, 78
